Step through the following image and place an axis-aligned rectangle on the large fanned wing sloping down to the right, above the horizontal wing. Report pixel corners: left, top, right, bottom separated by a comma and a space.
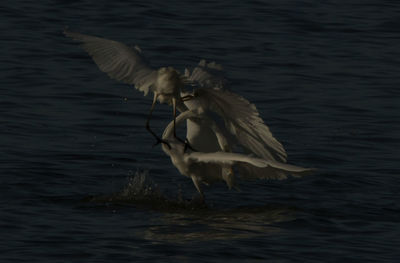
194, 88, 286, 162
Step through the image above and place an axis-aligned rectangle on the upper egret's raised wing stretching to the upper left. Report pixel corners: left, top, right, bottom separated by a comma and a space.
64, 30, 157, 95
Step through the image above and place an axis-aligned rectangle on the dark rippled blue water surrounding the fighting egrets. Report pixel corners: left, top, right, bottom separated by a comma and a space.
0, 1, 400, 262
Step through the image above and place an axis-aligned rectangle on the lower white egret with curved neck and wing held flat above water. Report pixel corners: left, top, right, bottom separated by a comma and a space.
162, 110, 312, 199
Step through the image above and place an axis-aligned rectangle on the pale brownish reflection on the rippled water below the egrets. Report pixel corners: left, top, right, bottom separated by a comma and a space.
143, 206, 295, 243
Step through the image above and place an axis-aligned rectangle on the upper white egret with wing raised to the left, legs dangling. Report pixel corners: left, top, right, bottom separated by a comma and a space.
64, 30, 186, 147
